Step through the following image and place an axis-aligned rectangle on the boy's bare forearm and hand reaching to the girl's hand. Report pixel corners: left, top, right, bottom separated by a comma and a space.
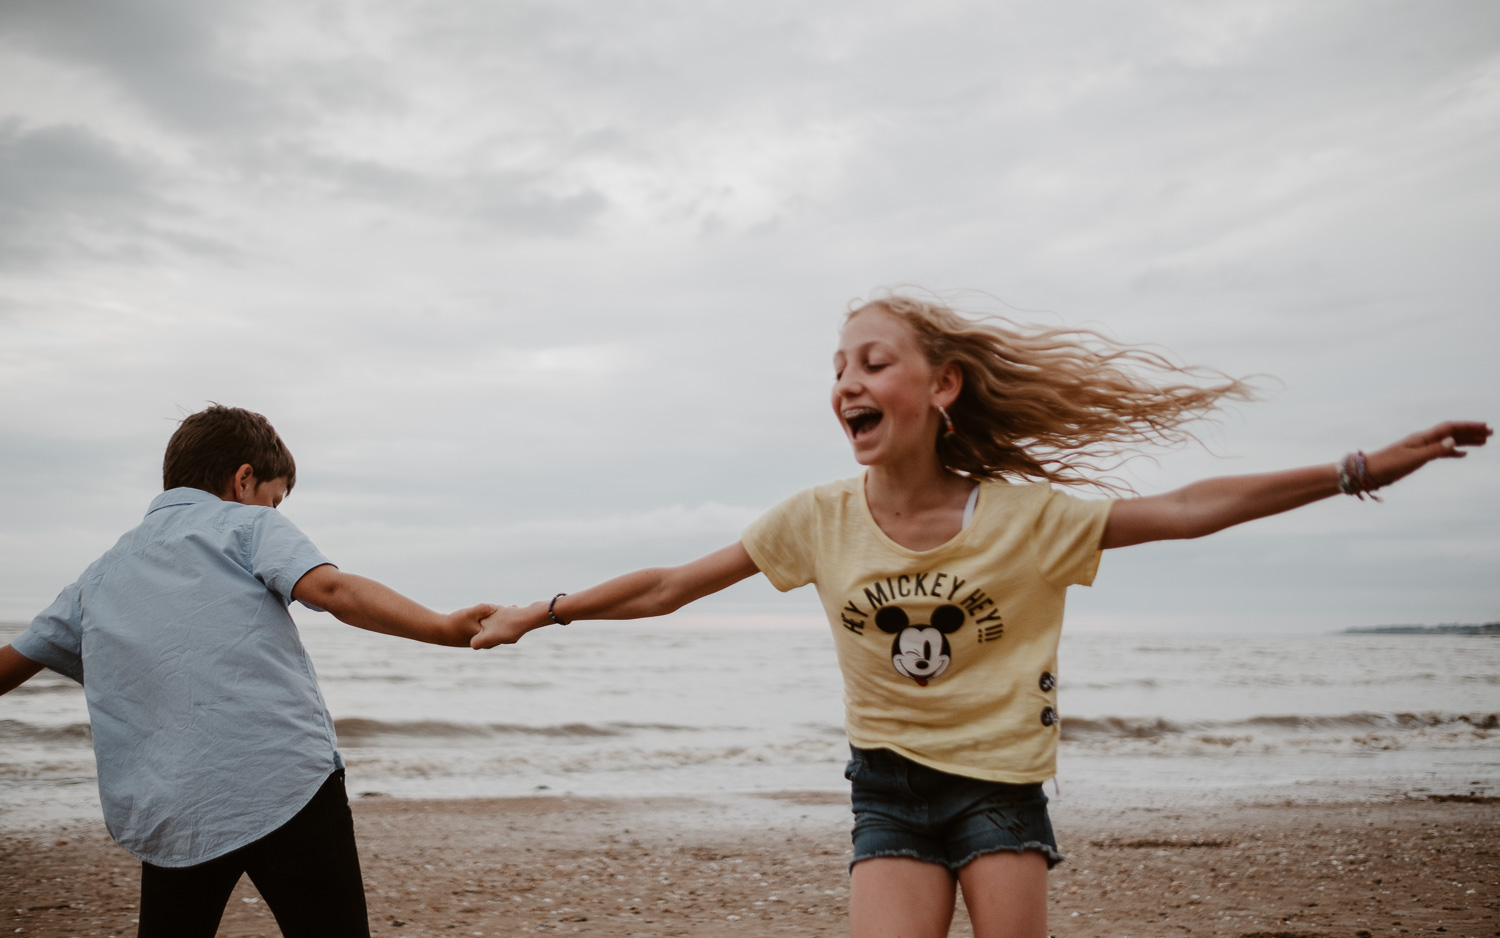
291, 563, 497, 647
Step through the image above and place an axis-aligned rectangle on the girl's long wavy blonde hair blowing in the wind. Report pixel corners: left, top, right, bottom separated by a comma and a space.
849, 293, 1256, 492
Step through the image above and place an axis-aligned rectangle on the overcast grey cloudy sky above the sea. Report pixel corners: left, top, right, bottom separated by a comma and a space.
0, 0, 1500, 630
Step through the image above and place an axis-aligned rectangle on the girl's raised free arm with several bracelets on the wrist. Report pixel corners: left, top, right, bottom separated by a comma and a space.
1100, 422, 1493, 548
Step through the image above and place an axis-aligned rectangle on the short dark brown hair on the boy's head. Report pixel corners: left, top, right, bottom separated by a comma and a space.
162, 404, 297, 495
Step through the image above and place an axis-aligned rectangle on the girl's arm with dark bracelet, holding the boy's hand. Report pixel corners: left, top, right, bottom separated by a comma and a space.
470, 540, 761, 648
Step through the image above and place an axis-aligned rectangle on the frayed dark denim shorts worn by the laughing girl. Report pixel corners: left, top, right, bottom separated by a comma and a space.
845, 746, 1062, 872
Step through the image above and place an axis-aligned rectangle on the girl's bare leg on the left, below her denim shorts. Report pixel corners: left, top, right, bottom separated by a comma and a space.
849, 857, 954, 938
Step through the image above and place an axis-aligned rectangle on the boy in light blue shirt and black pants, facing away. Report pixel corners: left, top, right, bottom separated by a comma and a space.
0, 405, 495, 938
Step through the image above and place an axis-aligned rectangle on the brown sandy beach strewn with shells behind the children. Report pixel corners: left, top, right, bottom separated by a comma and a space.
0, 792, 1500, 938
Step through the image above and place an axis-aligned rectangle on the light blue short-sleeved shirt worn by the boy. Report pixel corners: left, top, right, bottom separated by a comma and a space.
12, 488, 344, 866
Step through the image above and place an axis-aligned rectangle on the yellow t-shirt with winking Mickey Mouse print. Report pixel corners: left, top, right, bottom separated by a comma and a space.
741, 476, 1112, 783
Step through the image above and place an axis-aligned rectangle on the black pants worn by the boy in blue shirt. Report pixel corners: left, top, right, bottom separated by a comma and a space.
137, 770, 371, 938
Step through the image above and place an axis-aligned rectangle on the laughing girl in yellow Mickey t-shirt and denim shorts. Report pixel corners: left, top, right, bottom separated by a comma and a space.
473, 296, 1491, 938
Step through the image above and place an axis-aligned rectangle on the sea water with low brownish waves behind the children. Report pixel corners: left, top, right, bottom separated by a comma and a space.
0, 620, 1500, 828
